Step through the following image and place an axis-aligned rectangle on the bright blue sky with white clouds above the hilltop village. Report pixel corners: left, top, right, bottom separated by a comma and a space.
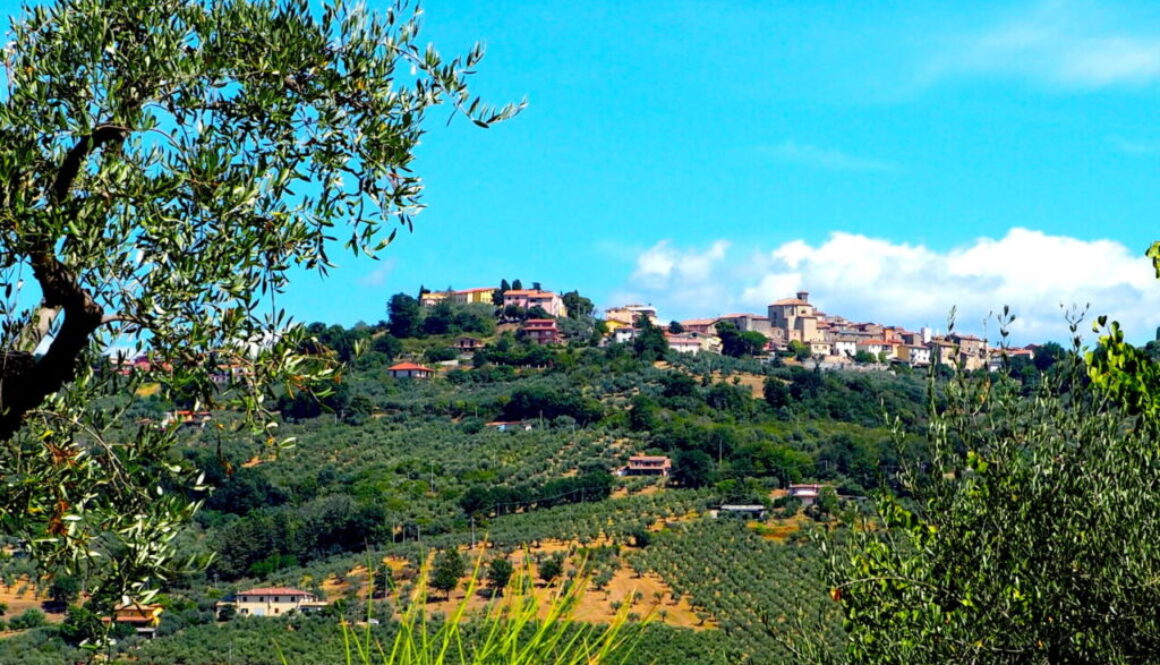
197, 0, 1160, 341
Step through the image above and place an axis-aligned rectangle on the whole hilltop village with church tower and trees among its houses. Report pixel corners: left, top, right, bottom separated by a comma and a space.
419, 284, 1035, 370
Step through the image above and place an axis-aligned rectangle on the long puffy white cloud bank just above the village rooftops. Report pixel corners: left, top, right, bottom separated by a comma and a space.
624, 229, 1160, 342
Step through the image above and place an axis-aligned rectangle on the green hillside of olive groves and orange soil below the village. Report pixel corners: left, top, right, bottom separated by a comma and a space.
0, 317, 1053, 665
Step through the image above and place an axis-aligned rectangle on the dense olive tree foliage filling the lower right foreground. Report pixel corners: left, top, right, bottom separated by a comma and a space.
826, 308, 1160, 664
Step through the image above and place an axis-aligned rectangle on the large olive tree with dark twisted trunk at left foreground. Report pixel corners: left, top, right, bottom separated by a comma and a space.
0, 0, 519, 598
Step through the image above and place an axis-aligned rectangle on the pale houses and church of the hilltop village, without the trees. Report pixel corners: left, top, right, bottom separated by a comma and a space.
407, 283, 1035, 376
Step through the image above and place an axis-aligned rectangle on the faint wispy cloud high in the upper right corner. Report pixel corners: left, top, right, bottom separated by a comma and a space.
926, 1, 1160, 89
